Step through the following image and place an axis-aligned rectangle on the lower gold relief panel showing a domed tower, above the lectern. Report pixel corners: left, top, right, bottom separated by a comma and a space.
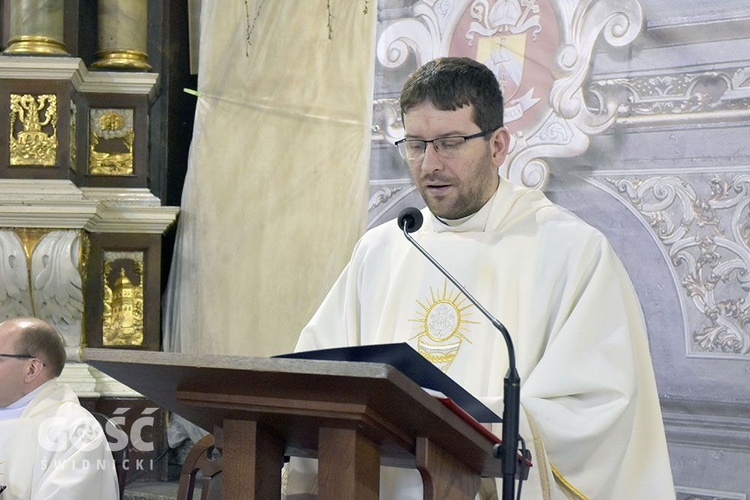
102, 252, 144, 346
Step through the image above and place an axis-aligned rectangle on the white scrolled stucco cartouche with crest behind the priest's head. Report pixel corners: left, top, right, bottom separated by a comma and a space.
375, 0, 643, 189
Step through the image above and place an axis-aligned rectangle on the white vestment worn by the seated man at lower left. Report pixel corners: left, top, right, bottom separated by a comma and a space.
0, 381, 119, 500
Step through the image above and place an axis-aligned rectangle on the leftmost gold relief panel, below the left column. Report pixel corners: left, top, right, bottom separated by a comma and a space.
10, 94, 57, 167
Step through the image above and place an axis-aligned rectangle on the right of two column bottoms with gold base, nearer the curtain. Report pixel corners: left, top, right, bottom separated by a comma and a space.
92, 0, 151, 71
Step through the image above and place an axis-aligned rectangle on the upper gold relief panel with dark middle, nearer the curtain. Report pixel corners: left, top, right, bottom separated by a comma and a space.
88, 109, 135, 175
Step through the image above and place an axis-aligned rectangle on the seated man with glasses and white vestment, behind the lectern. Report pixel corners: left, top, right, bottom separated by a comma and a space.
0, 318, 119, 500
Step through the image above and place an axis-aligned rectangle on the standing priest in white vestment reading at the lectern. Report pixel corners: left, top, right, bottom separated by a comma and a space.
287, 58, 675, 500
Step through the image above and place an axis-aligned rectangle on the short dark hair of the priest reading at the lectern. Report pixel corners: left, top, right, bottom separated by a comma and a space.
401, 57, 503, 132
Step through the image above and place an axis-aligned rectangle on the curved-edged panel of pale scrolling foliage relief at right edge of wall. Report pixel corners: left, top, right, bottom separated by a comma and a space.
590, 174, 750, 359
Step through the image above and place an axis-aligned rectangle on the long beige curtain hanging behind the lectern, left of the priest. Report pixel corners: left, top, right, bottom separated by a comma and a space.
164, 0, 376, 356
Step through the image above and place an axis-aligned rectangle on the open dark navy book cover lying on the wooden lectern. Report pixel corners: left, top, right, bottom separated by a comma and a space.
274, 342, 502, 423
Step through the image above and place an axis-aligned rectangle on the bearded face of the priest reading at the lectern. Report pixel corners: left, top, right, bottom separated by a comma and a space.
404, 102, 508, 219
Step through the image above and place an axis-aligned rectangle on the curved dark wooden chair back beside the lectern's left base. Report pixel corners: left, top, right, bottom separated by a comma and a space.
177, 434, 221, 500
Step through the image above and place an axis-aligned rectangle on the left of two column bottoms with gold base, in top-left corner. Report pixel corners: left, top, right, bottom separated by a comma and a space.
3, 0, 67, 56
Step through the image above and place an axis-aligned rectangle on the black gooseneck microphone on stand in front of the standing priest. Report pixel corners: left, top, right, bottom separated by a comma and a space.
397, 207, 530, 500
